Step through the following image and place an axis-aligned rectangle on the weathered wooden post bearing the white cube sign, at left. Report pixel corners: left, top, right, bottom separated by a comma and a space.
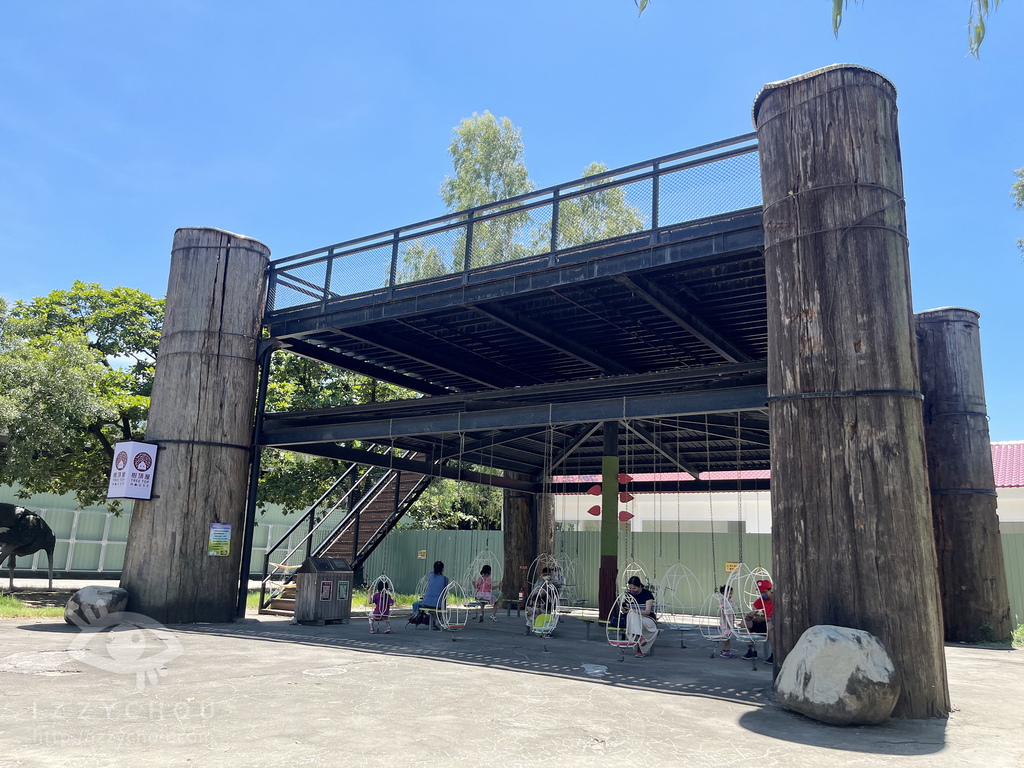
121, 227, 270, 624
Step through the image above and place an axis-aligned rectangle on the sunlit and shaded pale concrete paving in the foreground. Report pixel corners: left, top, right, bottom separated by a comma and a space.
0, 611, 1024, 768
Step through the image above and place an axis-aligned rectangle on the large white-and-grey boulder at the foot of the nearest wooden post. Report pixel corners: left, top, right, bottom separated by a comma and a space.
775, 625, 900, 725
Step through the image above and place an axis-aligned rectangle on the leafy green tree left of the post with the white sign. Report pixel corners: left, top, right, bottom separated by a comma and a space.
0, 282, 164, 512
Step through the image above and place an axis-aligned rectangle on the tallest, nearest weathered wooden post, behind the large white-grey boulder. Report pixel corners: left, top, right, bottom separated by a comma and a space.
754, 65, 949, 718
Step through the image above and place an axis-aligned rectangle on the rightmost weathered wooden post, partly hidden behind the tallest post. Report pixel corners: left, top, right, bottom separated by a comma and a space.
914, 307, 1013, 642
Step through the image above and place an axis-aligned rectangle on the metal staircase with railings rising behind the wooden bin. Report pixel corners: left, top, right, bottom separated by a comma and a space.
259, 452, 432, 615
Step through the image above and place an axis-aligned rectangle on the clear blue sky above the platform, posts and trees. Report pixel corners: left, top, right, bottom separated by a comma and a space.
0, 0, 1024, 440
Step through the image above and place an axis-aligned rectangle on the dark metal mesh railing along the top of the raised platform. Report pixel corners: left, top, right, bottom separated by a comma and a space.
266, 133, 761, 312
